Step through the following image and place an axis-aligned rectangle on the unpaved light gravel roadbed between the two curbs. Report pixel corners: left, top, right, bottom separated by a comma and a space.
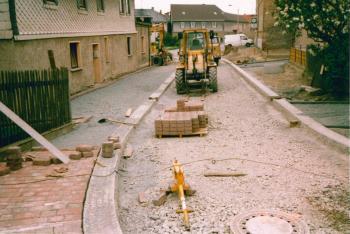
118, 63, 349, 234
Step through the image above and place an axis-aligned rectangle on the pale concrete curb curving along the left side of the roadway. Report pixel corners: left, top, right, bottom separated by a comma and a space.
83, 74, 175, 234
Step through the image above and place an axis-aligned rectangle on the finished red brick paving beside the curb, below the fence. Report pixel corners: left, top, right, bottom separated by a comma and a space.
0, 151, 97, 233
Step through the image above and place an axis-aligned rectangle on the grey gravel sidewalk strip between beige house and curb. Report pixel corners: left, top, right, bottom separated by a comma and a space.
53, 65, 174, 147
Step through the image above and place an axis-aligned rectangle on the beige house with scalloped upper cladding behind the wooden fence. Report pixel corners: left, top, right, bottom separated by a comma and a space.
0, 0, 149, 94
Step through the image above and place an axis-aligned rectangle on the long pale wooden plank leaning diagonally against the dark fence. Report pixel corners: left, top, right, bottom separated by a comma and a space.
0, 102, 69, 163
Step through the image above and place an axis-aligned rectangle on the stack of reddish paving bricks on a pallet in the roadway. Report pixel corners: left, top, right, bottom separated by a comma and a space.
155, 99, 208, 138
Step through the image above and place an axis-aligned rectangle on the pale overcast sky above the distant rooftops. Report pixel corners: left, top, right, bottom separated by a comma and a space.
135, 0, 256, 14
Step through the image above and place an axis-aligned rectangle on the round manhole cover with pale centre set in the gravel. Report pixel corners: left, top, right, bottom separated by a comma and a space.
230, 210, 310, 234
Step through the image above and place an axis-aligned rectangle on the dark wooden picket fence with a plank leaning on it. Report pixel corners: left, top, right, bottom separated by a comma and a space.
0, 68, 72, 147
